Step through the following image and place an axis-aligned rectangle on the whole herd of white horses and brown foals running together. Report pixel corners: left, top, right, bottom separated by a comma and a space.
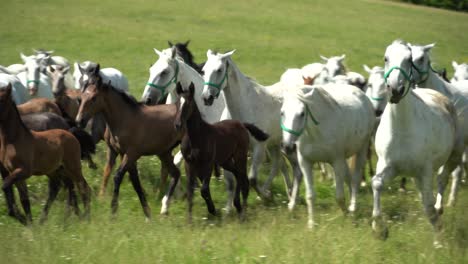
0, 40, 468, 246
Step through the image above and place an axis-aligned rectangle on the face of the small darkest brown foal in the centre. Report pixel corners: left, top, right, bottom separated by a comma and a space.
174, 83, 195, 132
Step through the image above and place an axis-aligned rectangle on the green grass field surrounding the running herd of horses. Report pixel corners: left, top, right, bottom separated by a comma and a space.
0, 0, 468, 263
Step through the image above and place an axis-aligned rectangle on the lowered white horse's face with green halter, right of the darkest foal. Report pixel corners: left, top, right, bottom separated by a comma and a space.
281, 95, 307, 154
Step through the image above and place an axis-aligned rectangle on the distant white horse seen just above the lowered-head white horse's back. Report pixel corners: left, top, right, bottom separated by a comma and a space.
315, 54, 367, 92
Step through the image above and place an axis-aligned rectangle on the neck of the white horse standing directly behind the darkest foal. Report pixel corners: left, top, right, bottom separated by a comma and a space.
223, 59, 268, 120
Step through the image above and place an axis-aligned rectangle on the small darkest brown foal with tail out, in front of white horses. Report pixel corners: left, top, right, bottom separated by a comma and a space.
174, 83, 268, 219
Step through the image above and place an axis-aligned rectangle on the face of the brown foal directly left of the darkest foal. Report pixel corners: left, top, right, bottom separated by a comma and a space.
75, 76, 106, 126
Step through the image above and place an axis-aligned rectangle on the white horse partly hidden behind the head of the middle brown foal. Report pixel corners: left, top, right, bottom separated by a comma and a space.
73, 61, 128, 92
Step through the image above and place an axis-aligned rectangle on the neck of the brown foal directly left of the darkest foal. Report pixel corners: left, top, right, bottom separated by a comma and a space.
102, 87, 138, 136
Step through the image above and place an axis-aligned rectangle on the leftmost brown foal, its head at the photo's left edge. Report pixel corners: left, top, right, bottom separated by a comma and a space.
0, 84, 91, 223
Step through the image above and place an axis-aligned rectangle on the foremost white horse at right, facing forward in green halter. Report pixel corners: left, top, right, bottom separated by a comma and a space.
372, 41, 463, 246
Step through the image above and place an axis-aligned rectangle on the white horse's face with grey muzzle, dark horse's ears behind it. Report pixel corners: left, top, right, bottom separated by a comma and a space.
141, 48, 179, 105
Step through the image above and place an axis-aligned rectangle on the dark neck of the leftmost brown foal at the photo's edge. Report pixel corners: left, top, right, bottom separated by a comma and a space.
0, 103, 31, 143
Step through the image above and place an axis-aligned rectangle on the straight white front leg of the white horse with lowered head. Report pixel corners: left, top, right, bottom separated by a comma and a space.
298, 152, 315, 229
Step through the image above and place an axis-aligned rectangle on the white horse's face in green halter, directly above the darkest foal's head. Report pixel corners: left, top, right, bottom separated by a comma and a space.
202, 50, 235, 105
